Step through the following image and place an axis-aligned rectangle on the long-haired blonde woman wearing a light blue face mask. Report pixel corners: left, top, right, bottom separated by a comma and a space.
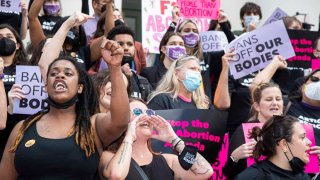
148, 56, 210, 110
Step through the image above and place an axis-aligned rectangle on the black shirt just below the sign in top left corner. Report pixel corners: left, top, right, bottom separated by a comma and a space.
0, 11, 22, 34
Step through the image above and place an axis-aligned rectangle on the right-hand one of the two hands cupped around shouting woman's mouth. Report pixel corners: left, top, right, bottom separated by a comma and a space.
150, 116, 177, 142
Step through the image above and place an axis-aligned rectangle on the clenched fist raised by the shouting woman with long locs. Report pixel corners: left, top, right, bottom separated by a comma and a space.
101, 38, 124, 67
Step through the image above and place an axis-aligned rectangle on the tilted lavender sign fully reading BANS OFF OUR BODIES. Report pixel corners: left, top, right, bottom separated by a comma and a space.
225, 21, 295, 79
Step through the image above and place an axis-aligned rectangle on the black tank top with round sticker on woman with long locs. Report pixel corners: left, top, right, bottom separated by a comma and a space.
14, 123, 99, 179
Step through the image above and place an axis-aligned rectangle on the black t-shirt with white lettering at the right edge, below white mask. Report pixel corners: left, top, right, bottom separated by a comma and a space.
287, 101, 320, 146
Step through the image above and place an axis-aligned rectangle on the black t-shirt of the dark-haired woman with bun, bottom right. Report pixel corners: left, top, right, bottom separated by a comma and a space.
235, 160, 310, 180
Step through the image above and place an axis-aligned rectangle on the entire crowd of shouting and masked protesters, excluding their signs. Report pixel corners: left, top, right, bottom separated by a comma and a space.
0, 0, 320, 180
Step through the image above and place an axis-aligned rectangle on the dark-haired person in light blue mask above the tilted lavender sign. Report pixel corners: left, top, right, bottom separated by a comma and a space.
233, 2, 262, 36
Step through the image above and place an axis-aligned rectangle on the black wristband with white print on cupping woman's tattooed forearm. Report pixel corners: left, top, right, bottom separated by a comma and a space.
178, 145, 198, 170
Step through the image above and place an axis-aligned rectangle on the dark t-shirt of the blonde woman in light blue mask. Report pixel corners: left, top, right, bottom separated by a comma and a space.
148, 93, 197, 110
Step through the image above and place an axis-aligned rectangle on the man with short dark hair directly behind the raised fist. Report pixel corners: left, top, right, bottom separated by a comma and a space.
107, 26, 152, 101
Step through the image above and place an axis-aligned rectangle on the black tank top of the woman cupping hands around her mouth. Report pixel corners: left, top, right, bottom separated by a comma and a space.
126, 155, 174, 180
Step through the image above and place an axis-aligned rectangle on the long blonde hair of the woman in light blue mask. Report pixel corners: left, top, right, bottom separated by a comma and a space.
148, 56, 209, 109
